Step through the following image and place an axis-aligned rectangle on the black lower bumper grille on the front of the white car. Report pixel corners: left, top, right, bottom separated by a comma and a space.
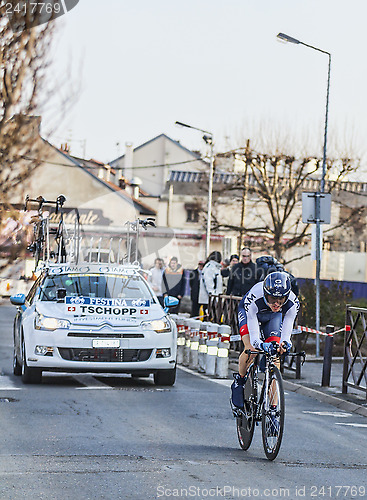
58, 347, 153, 363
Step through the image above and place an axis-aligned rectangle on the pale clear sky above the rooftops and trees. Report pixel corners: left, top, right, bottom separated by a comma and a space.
42, 0, 367, 166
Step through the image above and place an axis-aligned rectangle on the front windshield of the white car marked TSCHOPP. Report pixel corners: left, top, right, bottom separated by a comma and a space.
39, 274, 154, 301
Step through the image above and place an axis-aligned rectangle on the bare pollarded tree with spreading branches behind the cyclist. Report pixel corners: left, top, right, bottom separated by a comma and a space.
213, 142, 360, 260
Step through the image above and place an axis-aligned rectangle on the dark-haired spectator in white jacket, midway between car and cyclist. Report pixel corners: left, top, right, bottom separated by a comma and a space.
199, 252, 223, 315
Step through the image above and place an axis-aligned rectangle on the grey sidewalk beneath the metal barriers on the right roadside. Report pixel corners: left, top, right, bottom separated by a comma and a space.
230, 355, 367, 417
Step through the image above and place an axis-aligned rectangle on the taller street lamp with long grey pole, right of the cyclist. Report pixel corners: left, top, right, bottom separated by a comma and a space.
277, 33, 331, 356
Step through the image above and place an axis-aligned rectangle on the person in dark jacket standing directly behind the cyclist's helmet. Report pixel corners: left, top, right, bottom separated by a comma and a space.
226, 247, 261, 297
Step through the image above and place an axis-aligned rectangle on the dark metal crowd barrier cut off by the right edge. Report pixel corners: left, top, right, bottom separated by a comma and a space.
342, 306, 367, 399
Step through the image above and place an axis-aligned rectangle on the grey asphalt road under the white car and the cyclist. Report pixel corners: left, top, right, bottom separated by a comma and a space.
0, 306, 367, 500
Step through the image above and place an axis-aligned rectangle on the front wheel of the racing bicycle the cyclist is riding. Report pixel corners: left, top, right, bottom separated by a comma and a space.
261, 367, 285, 460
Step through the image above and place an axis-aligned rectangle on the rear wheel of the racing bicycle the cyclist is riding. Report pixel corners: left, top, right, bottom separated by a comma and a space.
236, 364, 256, 450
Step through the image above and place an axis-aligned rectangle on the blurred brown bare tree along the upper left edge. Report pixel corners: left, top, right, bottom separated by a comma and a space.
0, 1, 54, 221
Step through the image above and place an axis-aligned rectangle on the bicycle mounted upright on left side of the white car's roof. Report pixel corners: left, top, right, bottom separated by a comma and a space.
24, 194, 72, 270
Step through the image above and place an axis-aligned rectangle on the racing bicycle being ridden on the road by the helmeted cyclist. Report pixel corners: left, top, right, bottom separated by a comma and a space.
231, 349, 306, 460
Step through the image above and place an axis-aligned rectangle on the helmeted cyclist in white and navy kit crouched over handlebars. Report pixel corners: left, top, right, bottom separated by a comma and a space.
231, 272, 299, 408
